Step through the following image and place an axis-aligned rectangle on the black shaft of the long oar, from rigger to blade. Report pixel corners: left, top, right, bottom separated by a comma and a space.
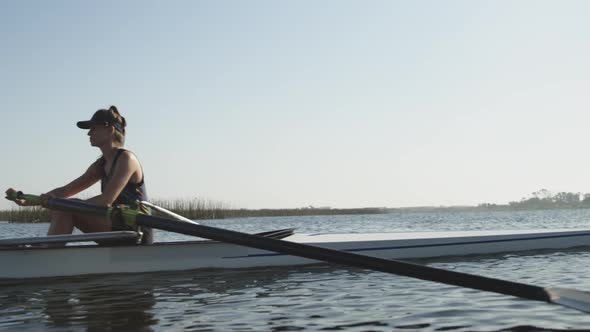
136, 215, 551, 302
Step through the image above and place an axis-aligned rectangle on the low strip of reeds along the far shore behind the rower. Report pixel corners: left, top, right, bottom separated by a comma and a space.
0, 198, 388, 223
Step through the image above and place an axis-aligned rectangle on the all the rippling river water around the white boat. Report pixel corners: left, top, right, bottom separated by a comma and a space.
0, 209, 590, 331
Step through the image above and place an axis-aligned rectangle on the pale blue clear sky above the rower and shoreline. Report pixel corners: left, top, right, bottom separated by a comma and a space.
0, 0, 590, 209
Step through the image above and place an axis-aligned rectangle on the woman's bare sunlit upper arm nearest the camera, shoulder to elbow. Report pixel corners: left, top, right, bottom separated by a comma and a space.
87, 151, 140, 206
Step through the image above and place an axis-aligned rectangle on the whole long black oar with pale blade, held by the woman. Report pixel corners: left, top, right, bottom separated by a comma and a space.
7, 193, 590, 313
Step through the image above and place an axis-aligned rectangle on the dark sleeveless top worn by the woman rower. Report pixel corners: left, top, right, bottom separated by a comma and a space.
99, 149, 154, 244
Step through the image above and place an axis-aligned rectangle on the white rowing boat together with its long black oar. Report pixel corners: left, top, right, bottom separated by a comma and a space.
5, 190, 590, 313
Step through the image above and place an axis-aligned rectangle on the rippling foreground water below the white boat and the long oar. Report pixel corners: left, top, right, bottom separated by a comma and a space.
0, 256, 590, 332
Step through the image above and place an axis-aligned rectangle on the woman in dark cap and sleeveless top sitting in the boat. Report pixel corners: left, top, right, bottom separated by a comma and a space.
7, 106, 153, 244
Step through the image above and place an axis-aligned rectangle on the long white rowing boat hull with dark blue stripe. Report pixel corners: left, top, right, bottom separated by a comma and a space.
0, 229, 590, 282
